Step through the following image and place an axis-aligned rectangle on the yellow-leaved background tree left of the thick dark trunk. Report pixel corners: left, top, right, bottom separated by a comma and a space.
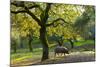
11, 11, 39, 52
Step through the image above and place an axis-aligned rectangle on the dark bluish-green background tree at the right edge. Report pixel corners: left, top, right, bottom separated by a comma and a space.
74, 6, 95, 39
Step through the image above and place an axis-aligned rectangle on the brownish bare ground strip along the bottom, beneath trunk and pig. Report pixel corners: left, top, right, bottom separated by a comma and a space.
11, 51, 95, 67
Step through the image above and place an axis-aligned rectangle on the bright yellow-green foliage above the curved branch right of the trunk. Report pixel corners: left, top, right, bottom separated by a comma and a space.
48, 4, 82, 23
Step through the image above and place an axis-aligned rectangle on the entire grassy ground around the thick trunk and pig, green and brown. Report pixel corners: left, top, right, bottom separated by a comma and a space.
11, 40, 95, 67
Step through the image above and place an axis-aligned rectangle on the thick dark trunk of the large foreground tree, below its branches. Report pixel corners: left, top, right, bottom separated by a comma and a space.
40, 27, 49, 61
